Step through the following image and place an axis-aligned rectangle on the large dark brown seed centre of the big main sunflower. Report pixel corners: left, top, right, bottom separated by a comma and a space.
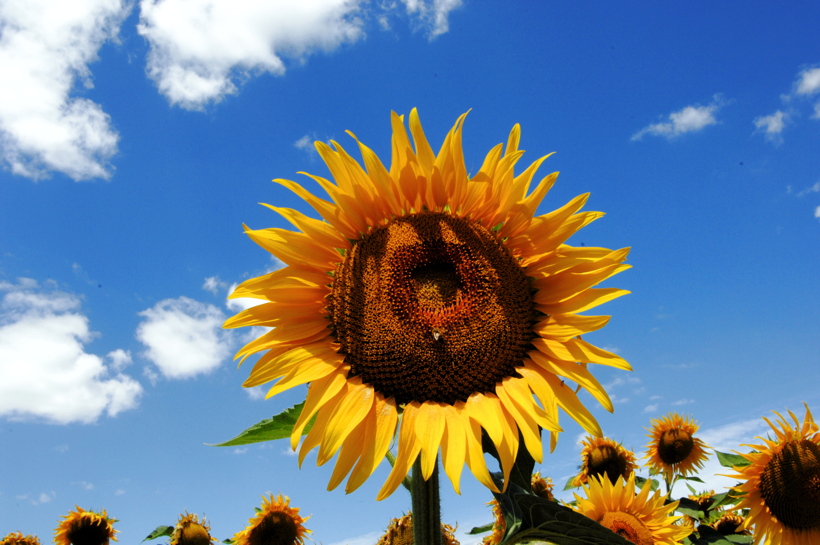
328, 212, 535, 404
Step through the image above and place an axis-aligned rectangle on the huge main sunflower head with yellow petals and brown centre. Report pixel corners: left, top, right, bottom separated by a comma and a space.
225, 110, 630, 499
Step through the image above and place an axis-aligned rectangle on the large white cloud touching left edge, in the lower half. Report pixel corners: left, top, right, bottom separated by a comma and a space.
0, 279, 142, 424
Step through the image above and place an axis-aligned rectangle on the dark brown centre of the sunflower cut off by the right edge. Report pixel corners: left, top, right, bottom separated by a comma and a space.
760, 439, 820, 530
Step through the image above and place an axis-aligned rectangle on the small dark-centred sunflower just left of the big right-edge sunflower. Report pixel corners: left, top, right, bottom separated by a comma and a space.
644, 413, 709, 480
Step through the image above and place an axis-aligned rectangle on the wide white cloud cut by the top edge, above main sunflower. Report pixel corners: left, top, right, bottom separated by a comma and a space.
137, 0, 461, 110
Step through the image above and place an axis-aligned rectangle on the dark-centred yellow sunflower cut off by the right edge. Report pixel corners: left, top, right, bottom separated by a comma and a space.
730, 405, 820, 545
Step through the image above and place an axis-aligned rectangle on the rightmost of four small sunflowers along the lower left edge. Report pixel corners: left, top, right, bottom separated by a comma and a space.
233, 494, 311, 545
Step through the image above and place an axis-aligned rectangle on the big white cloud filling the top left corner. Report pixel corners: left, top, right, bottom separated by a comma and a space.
0, 0, 131, 180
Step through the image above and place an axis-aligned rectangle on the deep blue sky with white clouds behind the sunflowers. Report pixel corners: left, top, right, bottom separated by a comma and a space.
0, 0, 820, 545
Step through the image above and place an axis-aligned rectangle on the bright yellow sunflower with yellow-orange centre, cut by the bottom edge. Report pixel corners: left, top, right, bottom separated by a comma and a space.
574, 473, 691, 545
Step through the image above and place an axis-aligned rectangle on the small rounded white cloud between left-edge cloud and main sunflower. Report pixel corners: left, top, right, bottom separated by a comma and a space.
137, 297, 231, 379
